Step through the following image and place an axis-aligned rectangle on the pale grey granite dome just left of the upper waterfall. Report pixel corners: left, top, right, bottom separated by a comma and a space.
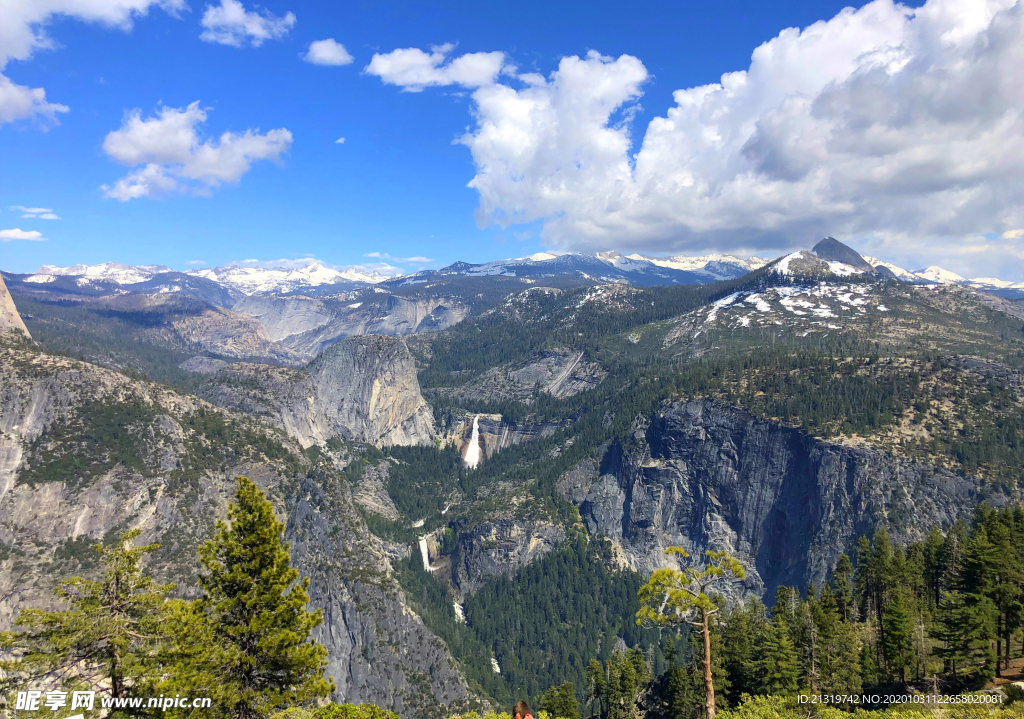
200, 335, 434, 447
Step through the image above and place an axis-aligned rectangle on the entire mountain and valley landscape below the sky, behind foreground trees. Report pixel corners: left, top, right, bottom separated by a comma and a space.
0, 239, 1024, 717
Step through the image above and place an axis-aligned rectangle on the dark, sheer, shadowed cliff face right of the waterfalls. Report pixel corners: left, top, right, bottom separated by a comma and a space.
558, 400, 1005, 598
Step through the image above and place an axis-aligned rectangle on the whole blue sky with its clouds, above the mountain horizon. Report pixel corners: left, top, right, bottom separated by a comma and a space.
0, 0, 1024, 280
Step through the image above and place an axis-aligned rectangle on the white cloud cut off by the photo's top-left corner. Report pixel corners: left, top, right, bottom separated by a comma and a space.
0, 0, 186, 127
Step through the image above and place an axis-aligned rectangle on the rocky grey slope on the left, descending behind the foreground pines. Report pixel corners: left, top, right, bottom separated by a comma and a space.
0, 342, 474, 719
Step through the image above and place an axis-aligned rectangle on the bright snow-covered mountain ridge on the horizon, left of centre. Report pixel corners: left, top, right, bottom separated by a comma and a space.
186, 261, 392, 295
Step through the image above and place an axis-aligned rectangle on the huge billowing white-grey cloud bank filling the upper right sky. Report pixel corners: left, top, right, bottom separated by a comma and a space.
368, 0, 1024, 278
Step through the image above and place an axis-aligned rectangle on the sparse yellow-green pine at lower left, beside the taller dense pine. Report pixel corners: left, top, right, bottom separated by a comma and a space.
7, 530, 174, 697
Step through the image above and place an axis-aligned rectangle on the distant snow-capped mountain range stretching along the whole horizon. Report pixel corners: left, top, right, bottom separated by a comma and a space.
7, 243, 1024, 299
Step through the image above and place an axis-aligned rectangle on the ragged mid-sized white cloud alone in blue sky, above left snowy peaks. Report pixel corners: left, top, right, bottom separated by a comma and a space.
102, 101, 292, 202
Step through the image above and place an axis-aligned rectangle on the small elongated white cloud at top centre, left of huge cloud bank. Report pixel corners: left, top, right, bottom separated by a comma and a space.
364, 43, 505, 92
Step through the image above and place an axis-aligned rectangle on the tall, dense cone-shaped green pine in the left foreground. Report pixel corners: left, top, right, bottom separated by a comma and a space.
176, 476, 334, 719
